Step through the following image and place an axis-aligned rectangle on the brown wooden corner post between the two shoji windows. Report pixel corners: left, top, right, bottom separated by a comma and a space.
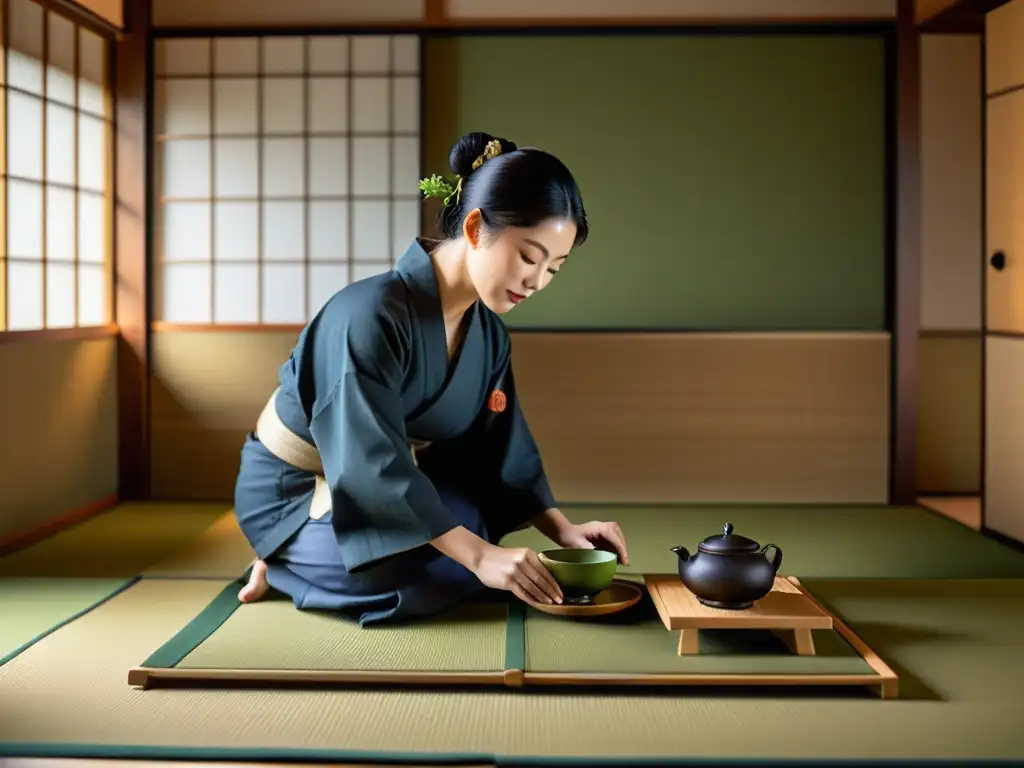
114, 0, 153, 500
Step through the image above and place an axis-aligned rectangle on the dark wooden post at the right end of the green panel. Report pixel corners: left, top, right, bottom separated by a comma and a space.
890, 0, 921, 504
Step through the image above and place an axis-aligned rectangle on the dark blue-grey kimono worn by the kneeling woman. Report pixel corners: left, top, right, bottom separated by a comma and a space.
236, 241, 555, 624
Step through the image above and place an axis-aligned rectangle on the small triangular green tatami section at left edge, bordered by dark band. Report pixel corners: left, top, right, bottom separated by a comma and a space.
0, 578, 134, 666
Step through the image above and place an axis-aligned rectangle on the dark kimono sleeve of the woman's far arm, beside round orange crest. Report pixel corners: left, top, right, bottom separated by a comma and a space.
484, 342, 556, 519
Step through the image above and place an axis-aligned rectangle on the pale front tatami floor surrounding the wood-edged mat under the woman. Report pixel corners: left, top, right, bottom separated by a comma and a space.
0, 580, 1024, 765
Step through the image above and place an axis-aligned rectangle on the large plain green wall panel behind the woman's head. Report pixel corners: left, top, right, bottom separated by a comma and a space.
426, 33, 886, 331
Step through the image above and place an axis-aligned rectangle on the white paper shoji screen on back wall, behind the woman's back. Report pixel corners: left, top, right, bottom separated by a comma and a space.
155, 35, 421, 324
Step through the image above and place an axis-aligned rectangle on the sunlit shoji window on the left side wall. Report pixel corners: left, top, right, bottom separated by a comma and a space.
0, 0, 113, 331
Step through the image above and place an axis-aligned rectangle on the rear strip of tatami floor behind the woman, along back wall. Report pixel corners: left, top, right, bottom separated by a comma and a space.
0, 503, 1024, 579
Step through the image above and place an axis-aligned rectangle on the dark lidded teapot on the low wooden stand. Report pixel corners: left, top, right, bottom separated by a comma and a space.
672, 522, 782, 610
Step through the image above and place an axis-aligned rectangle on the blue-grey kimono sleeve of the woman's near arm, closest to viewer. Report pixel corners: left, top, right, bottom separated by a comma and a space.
310, 303, 460, 572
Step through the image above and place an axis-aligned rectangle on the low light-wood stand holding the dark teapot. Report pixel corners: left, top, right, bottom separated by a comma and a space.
644, 575, 833, 655
